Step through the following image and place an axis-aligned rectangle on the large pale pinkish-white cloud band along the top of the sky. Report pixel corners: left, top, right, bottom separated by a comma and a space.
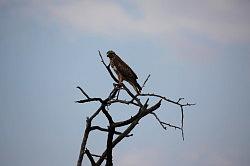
47, 0, 250, 43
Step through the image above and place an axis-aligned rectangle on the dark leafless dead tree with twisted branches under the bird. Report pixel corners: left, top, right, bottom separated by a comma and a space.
76, 51, 195, 166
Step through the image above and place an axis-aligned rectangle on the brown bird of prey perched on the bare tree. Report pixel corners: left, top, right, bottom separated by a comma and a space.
107, 50, 142, 94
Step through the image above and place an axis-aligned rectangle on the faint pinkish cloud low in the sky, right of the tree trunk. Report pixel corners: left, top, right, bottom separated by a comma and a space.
113, 143, 248, 166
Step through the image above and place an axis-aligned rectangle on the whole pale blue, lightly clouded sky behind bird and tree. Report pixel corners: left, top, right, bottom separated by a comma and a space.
0, 0, 250, 166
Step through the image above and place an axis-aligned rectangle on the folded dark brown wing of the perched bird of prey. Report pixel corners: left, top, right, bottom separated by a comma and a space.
114, 56, 138, 80
